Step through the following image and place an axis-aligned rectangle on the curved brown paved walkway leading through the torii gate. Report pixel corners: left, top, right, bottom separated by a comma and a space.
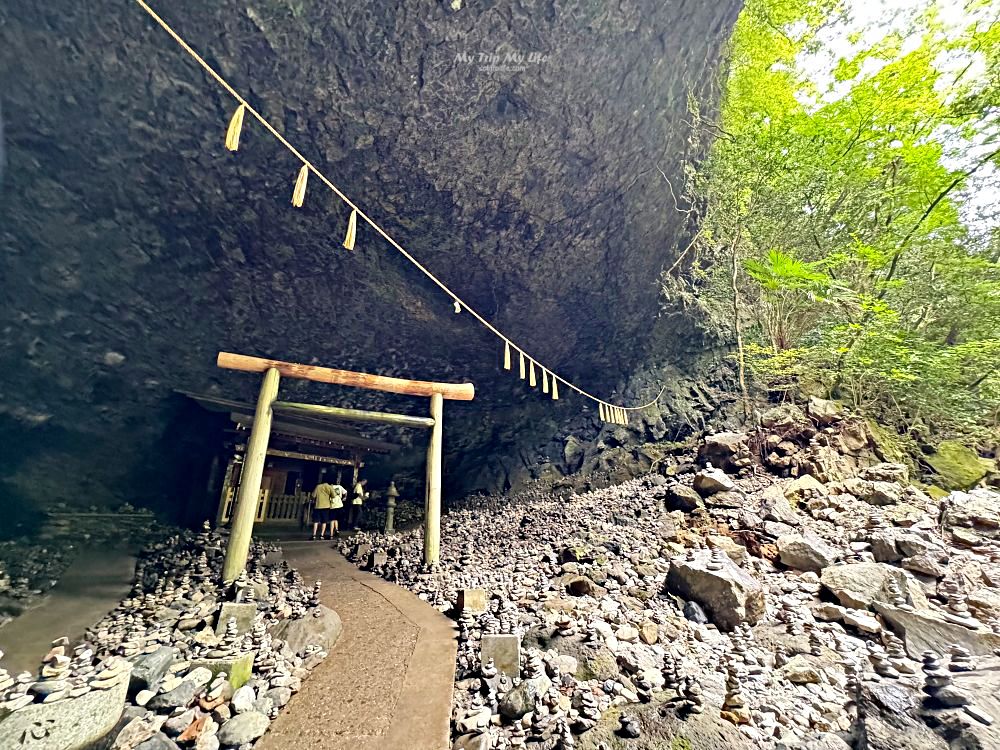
256, 541, 457, 750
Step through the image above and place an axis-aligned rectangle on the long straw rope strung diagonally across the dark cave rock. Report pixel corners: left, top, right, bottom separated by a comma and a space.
135, 0, 666, 421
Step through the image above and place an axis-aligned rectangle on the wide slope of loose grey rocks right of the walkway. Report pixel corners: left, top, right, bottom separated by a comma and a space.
342, 414, 1000, 750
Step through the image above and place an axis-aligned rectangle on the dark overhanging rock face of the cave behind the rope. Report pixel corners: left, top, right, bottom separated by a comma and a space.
0, 0, 739, 524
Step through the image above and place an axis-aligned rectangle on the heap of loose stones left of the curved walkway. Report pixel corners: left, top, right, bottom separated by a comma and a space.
0, 522, 339, 750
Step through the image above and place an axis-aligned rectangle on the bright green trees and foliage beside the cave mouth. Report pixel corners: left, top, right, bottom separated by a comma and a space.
680, 0, 1000, 441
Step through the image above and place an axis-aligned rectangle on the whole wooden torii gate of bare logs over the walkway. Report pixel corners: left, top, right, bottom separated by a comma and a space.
216, 352, 476, 582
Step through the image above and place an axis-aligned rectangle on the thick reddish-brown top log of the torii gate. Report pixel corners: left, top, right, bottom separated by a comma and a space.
216, 352, 476, 401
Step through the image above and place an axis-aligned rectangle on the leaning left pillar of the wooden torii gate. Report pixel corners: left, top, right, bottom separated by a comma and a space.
222, 367, 281, 583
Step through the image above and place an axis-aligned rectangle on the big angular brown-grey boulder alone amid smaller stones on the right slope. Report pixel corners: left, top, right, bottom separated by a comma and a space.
667, 553, 765, 630
